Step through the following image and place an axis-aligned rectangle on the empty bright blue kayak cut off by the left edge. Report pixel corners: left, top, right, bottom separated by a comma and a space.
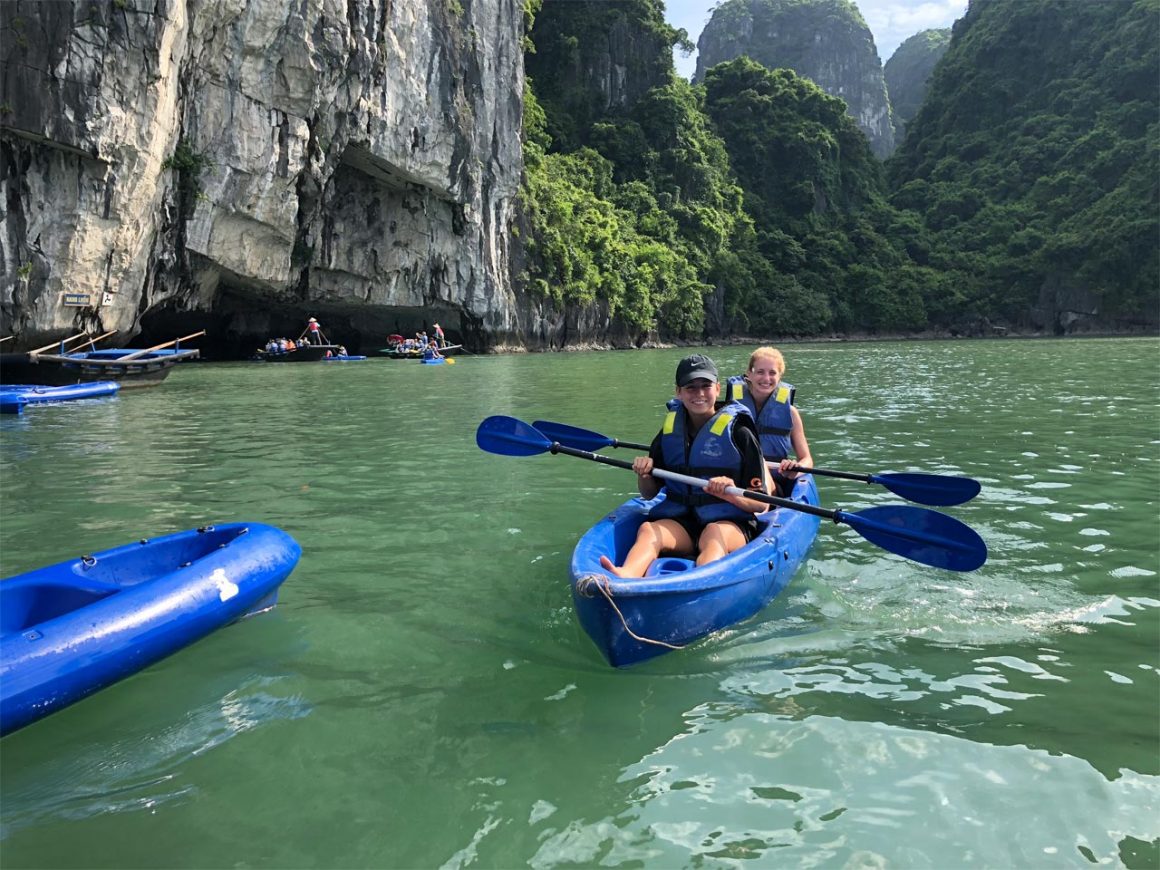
0, 523, 302, 734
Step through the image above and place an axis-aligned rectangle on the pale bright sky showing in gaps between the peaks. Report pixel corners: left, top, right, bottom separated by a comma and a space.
665, 0, 967, 79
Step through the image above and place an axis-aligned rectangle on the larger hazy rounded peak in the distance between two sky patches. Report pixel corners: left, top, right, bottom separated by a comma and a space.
695, 0, 894, 158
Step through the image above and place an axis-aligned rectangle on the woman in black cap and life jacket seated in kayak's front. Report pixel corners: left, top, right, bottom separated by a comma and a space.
600, 354, 769, 578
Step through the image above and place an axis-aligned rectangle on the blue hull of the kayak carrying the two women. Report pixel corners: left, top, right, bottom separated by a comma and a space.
571, 474, 820, 667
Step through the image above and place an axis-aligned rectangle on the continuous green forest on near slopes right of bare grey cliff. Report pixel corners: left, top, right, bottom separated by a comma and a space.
523, 0, 1160, 338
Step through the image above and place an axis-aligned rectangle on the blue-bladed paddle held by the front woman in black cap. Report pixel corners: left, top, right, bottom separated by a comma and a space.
476, 416, 987, 571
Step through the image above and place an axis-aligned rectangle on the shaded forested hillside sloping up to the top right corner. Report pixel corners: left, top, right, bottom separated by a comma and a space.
889, 0, 1160, 331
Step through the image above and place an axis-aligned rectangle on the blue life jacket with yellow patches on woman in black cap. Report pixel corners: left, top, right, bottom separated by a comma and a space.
648, 399, 753, 523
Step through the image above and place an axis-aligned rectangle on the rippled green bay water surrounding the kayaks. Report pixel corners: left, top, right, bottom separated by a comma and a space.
0, 340, 1160, 868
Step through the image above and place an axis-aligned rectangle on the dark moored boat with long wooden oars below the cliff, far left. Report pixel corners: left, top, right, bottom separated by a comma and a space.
0, 329, 205, 390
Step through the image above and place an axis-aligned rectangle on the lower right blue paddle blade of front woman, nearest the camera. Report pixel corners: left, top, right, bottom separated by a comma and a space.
834, 505, 987, 571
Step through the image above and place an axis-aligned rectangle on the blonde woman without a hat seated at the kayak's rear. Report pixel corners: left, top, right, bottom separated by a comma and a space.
722, 347, 813, 495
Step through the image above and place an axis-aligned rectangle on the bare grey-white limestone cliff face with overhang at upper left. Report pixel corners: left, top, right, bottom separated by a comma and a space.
0, 0, 526, 350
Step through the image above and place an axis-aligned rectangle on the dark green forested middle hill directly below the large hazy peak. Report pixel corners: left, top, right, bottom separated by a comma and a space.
705, 58, 942, 334
